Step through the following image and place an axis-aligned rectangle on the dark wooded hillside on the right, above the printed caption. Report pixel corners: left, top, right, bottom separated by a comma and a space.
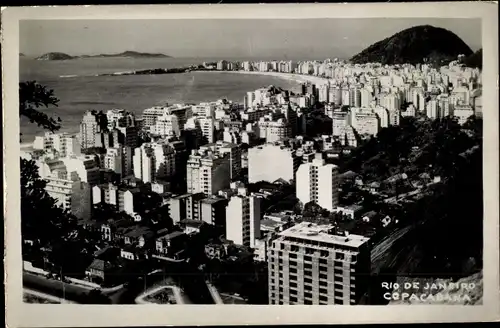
340, 116, 483, 279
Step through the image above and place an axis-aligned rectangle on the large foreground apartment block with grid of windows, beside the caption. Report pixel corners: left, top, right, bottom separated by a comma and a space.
267, 222, 371, 305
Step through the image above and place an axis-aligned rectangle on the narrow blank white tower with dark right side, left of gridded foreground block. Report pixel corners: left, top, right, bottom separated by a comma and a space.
226, 187, 261, 247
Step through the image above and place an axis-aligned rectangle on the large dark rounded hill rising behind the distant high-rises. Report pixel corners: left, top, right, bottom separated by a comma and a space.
351, 25, 472, 65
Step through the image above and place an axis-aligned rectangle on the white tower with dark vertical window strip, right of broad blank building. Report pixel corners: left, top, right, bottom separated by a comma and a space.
296, 153, 339, 211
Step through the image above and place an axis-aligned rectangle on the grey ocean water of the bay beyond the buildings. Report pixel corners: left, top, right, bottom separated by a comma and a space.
19, 58, 298, 143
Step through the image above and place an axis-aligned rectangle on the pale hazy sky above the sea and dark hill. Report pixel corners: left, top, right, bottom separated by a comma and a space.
19, 18, 481, 59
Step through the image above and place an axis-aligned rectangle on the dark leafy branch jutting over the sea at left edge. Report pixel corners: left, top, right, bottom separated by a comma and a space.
19, 81, 61, 138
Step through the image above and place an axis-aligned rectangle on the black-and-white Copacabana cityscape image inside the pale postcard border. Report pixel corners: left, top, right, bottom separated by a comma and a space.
2, 4, 498, 326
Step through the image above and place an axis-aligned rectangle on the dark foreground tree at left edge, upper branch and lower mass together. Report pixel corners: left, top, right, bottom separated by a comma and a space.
19, 81, 94, 273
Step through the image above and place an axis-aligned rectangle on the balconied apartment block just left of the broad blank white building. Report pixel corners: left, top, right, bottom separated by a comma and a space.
186, 150, 231, 195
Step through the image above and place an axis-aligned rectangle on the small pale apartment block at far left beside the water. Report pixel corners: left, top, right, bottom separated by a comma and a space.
33, 132, 81, 157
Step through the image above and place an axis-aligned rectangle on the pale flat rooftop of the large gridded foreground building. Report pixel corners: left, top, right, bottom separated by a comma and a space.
279, 222, 369, 248
